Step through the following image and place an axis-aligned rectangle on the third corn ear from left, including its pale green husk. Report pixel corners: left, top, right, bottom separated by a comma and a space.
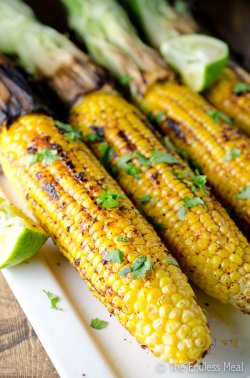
59, 0, 250, 229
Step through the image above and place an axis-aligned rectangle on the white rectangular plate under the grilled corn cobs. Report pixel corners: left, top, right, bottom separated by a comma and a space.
0, 175, 250, 378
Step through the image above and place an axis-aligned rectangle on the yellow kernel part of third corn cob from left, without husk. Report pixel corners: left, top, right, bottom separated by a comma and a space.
142, 82, 250, 230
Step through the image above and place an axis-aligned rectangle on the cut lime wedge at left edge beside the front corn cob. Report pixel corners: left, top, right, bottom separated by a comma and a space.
0, 198, 48, 269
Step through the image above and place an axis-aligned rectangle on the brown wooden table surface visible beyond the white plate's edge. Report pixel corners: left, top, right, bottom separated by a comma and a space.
0, 272, 58, 378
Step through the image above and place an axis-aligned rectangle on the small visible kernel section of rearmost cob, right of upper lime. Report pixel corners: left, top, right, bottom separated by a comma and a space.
205, 67, 250, 136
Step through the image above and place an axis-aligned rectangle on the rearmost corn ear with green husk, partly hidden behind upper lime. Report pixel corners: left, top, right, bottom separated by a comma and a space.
124, 0, 250, 135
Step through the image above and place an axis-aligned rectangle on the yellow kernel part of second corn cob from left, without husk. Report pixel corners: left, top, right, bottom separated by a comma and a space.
70, 92, 250, 312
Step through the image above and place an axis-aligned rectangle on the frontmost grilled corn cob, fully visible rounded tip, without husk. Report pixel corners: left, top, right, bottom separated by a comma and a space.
0, 115, 210, 363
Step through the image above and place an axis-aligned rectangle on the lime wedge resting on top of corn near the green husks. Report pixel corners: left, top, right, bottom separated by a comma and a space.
161, 34, 229, 92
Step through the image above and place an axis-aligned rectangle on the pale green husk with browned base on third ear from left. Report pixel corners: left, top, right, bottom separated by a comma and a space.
62, 0, 173, 96
